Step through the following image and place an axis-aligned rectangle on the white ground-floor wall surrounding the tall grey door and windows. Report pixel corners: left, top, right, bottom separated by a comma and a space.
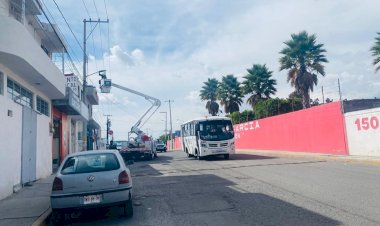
0, 64, 52, 199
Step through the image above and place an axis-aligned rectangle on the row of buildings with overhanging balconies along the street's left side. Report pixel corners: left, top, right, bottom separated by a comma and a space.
0, 0, 100, 199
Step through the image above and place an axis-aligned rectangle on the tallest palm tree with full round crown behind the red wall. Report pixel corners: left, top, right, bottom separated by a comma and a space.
280, 31, 328, 108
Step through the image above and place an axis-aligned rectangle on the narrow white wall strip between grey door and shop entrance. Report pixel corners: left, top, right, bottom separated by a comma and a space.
36, 114, 53, 179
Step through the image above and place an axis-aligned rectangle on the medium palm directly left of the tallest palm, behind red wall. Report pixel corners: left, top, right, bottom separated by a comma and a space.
242, 64, 277, 108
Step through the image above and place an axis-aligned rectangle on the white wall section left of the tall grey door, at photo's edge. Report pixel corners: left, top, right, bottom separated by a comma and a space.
0, 95, 22, 199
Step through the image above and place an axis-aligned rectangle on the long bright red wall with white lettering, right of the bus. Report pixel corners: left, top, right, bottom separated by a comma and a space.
234, 102, 348, 155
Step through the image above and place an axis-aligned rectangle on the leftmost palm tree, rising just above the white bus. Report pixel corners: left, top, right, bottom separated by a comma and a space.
199, 78, 219, 116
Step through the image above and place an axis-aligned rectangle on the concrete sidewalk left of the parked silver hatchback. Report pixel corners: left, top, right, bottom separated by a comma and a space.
0, 175, 55, 226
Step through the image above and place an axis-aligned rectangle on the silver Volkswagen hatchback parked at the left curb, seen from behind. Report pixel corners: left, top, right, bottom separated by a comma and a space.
50, 150, 133, 221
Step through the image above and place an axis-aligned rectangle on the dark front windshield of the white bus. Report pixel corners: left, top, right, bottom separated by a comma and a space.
199, 120, 234, 141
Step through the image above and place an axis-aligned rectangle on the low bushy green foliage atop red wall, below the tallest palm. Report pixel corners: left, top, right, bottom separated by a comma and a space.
255, 98, 302, 119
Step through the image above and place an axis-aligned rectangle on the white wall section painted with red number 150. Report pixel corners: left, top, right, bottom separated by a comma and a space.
344, 108, 380, 156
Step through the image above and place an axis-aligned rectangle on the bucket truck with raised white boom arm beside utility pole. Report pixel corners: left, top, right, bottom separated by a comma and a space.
99, 74, 161, 160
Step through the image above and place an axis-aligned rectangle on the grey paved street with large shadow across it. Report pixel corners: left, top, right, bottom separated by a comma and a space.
51, 151, 380, 225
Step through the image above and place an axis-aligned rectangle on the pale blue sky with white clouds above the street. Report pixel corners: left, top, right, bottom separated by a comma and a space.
44, 0, 380, 139
